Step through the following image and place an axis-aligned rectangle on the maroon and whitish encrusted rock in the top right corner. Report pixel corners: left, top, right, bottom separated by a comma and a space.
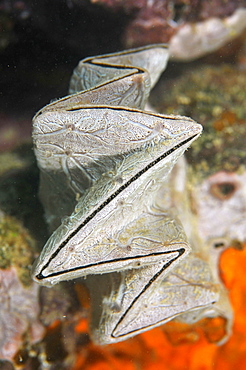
92, 0, 246, 60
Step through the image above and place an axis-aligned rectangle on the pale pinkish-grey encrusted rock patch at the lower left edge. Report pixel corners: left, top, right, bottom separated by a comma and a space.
0, 268, 44, 360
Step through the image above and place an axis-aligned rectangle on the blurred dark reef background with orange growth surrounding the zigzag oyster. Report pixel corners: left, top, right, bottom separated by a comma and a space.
0, 0, 246, 370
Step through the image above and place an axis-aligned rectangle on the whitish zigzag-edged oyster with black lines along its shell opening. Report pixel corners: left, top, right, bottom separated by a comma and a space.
30, 45, 219, 344
